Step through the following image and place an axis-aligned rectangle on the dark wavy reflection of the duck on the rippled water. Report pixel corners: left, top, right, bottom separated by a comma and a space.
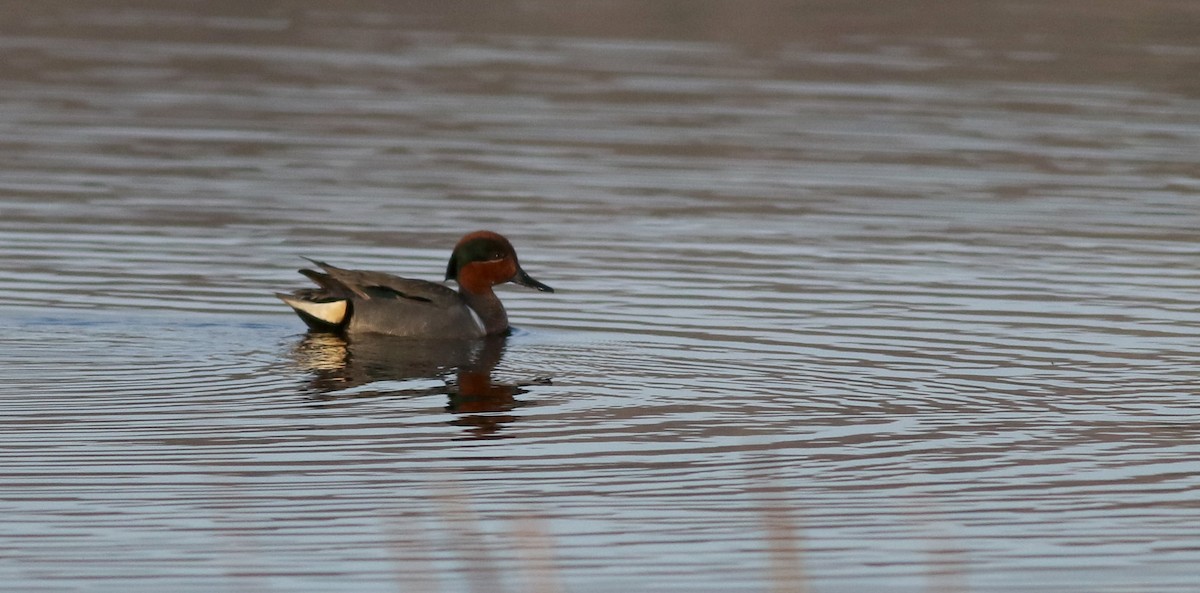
294, 333, 546, 437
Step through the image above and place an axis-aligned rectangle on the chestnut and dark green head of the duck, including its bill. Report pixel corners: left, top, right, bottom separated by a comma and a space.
446, 230, 554, 293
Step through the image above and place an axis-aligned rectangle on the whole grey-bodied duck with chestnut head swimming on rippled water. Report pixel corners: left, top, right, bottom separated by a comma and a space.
275, 230, 554, 339
